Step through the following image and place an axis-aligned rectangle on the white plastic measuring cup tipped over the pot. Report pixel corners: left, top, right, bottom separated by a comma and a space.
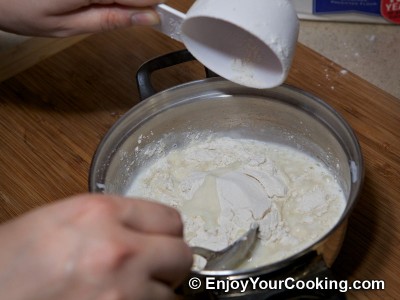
156, 0, 299, 88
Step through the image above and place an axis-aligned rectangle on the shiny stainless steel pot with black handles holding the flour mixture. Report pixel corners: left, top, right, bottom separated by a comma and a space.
89, 51, 364, 299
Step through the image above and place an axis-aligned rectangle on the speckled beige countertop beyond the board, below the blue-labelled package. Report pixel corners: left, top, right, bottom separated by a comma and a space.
299, 21, 400, 99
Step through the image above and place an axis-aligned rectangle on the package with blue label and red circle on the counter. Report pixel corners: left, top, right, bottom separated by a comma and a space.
292, 0, 400, 24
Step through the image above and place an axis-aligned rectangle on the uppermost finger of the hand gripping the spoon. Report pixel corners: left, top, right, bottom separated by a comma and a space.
38, 194, 183, 237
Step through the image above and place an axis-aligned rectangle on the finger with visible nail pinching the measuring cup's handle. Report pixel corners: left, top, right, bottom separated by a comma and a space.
51, 5, 160, 36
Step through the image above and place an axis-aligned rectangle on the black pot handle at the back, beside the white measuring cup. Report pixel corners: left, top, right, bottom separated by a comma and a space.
136, 49, 218, 101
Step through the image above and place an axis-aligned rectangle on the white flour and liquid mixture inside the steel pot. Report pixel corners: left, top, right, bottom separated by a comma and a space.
127, 138, 345, 268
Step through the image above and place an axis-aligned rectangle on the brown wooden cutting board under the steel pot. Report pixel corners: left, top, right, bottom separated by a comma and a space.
0, 1, 400, 299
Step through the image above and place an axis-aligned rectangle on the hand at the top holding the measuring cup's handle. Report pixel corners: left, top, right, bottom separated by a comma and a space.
0, 0, 163, 37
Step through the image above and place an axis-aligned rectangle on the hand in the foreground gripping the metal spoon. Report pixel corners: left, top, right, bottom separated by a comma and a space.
0, 195, 192, 300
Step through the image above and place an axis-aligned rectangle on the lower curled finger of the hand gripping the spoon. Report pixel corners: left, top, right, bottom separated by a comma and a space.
130, 235, 193, 287
